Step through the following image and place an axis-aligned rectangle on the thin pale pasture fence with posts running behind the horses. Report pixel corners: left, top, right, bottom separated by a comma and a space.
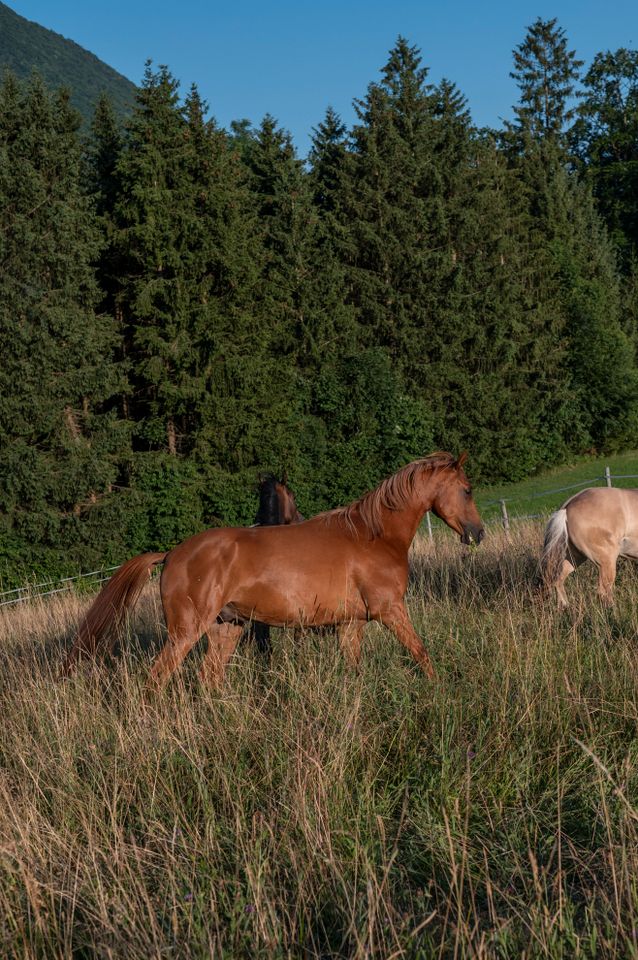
0, 467, 638, 607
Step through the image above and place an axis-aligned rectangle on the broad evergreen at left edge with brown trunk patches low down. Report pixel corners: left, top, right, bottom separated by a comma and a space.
0, 76, 126, 566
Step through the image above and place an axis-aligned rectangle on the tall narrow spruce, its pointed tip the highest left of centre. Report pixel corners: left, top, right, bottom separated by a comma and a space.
115, 64, 196, 455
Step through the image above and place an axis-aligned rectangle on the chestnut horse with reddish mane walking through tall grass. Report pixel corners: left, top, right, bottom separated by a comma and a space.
64, 453, 483, 686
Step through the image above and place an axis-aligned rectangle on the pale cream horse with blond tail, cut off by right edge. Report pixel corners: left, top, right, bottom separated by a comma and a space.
541, 487, 638, 608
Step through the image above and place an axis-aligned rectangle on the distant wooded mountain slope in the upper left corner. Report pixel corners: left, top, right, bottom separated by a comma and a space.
0, 3, 135, 122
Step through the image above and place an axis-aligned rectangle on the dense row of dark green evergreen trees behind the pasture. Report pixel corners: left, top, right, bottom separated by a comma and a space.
0, 20, 638, 578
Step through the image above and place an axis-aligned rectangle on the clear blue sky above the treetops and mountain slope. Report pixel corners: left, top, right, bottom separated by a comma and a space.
8, 0, 638, 156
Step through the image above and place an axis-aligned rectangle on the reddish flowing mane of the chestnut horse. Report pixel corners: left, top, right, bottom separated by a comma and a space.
319, 451, 456, 540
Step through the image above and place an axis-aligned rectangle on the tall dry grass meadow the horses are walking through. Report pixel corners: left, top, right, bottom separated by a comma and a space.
0, 523, 638, 960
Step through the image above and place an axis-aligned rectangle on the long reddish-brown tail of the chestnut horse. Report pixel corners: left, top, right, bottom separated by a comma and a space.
62, 551, 168, 677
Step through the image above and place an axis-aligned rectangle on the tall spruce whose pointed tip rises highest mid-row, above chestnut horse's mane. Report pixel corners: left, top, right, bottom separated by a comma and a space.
340, 37, 450, 376
